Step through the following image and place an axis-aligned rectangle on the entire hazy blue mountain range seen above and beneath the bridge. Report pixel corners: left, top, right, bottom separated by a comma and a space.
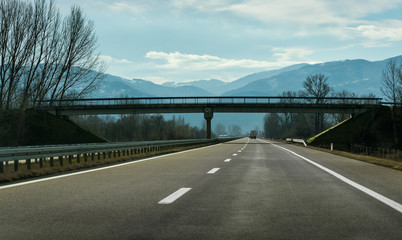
92, 56, 402, 133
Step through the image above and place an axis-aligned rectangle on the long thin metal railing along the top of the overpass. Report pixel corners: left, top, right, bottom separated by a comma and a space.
36, 97, 382, 107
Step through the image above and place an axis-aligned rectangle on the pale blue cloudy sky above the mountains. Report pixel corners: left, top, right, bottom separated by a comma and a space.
55, 0, 402, 83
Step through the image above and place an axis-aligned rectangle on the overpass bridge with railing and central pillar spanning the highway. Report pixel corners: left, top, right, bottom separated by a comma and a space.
36, 96, 382, 138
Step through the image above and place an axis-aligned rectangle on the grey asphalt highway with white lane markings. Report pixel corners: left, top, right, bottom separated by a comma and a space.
0, 138, 402, 239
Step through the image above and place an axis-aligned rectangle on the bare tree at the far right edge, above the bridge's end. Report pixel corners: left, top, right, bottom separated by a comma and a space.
380, 59, 402, 106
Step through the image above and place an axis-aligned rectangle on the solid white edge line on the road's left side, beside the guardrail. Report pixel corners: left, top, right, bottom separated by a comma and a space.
0, 143, 222, 190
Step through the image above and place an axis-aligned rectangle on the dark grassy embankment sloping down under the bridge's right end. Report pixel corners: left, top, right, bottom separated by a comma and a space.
308, 107, 402, 171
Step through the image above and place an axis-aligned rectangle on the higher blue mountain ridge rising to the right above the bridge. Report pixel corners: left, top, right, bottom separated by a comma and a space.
224, 57, 401, 96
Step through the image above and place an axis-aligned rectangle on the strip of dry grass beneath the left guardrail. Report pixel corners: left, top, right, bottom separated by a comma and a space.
0, 144, 211, 182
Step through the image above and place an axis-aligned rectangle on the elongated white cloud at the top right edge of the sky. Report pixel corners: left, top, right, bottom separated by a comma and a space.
216, 0, 402, 25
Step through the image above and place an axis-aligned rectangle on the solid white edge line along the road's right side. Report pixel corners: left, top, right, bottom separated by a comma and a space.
272, 144, 402, 213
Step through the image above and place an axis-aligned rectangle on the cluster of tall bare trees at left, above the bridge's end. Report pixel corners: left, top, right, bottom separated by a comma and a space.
0, 0, 105, 110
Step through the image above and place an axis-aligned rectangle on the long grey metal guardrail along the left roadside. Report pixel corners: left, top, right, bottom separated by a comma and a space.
0, 139, 216, 162
